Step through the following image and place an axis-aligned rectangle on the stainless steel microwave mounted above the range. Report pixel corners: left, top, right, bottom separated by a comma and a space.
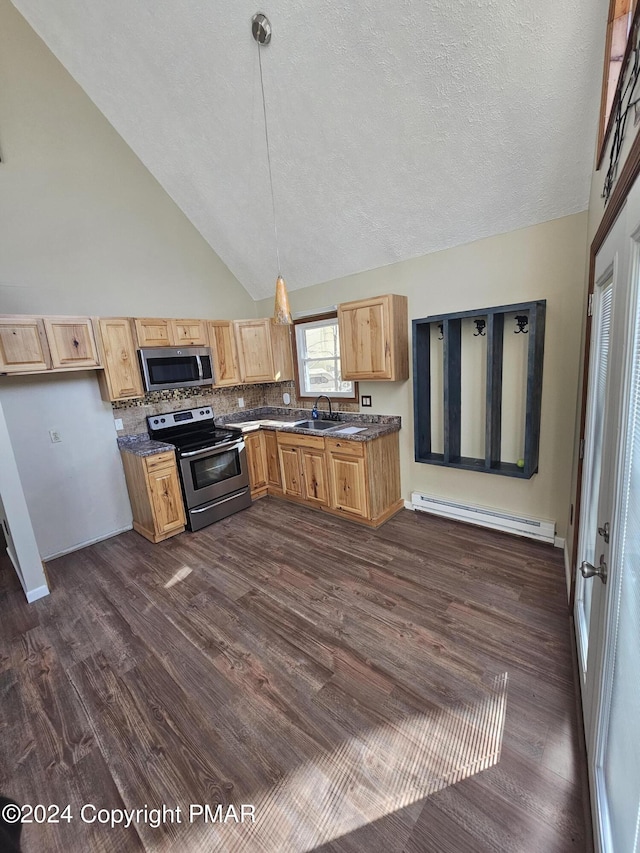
138, 347, 213, 391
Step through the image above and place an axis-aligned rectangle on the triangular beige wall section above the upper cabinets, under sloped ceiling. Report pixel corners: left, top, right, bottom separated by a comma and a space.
0, 0, 255, 318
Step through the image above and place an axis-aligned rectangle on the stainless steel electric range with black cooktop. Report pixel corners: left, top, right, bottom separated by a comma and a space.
147, 406, 251, 530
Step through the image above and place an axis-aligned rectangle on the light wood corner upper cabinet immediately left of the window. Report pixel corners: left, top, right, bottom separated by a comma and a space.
234, 318, 293, 382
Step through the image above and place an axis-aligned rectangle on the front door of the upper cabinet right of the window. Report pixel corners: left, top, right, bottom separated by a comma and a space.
338, 296, 391, 379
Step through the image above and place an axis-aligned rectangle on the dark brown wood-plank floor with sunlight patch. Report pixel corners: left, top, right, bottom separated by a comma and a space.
0, 499, 589, 853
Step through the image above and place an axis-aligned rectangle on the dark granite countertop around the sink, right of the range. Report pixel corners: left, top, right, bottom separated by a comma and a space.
216, 406, 401, 441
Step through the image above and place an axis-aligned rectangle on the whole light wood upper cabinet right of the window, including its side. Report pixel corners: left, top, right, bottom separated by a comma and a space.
338, 294, 409, 381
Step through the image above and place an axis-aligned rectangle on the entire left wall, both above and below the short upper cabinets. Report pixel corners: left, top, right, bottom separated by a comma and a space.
0, 0, 256, 558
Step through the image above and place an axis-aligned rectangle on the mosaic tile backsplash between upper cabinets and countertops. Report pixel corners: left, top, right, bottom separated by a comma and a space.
111, 381, 360, 435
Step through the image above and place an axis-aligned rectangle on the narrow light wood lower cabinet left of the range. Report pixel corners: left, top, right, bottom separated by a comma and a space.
120, 450, 186, 542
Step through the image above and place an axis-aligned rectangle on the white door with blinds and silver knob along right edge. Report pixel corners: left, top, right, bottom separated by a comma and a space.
575, 176, 640, 853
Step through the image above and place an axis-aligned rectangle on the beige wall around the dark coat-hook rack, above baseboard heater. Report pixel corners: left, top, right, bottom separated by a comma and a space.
258, 212, 587, 536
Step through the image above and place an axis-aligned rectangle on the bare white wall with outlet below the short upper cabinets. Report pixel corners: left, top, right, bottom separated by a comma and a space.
0, 371, 131, 560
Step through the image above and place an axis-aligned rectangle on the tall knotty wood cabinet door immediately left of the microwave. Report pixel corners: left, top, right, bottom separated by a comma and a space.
98, 317, 144, 400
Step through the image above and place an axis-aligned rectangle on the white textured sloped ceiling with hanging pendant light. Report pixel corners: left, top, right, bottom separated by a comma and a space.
13, 0, 608, 299
